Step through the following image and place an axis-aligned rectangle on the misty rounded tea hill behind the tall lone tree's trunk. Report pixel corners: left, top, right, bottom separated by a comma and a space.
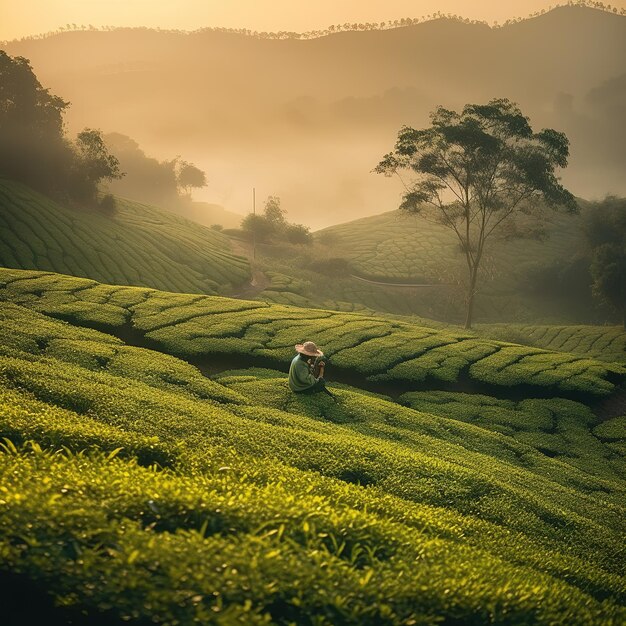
240, 203, 584, 325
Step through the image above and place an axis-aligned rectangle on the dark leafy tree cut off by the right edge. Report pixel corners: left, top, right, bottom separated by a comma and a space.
585, 196, 626, 329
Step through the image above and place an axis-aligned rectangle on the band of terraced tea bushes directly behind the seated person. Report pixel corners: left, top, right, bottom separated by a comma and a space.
0, 270, 626, 395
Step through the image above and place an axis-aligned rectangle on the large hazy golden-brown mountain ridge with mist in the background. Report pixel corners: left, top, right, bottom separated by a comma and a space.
6, 7, 626, 227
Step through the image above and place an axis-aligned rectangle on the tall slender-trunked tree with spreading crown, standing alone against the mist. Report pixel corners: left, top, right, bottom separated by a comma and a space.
374, 99, 578, 328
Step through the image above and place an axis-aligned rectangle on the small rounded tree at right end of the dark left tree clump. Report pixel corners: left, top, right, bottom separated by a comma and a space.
74, 128, 124, 200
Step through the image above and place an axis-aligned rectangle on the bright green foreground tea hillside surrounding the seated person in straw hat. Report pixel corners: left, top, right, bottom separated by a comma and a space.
0, 270, 626, 626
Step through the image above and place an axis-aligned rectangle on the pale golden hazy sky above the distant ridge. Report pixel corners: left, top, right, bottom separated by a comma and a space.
0, 0, 626, 40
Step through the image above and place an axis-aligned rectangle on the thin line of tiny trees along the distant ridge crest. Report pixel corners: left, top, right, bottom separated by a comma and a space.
0, 0, 626, 44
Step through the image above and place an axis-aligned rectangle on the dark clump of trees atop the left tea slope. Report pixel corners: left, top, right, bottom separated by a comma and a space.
0, 50, 123, 208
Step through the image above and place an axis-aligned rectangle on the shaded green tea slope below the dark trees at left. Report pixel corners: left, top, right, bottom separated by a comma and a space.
0, 179, 250, 293
